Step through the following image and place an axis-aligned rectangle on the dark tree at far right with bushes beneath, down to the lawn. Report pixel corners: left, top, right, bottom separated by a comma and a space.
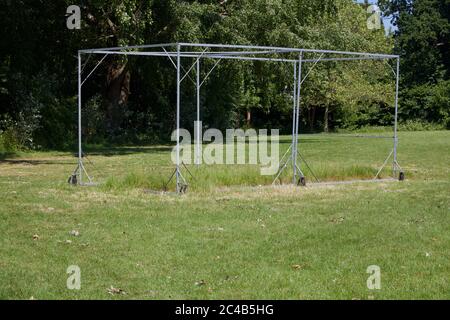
382, 0, 450, 128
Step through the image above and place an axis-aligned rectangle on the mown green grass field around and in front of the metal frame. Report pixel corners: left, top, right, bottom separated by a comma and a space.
0, 131, 450, 299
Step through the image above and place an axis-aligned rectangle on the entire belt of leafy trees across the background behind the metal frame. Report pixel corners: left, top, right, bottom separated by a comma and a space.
0, 0, 449, 148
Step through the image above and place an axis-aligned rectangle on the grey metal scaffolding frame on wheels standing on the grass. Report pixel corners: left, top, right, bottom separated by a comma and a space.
69, 43, 404, 193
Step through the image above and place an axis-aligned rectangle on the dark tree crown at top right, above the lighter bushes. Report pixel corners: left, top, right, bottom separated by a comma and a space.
382, 0, 450, 87
